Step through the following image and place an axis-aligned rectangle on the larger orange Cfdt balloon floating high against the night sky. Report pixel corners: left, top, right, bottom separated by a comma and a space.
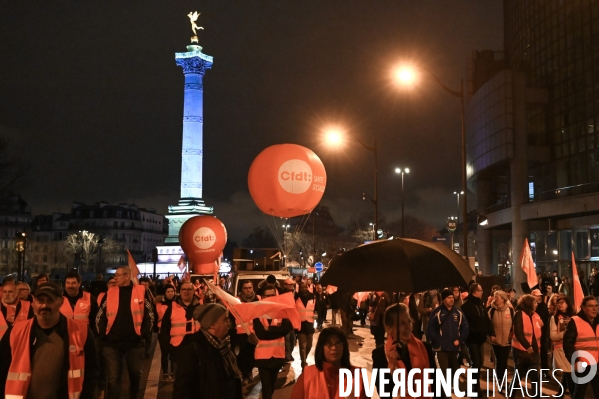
248, 144, 327, 218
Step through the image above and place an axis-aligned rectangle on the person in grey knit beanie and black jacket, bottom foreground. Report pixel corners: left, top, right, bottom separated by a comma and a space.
173, 303, 243, 399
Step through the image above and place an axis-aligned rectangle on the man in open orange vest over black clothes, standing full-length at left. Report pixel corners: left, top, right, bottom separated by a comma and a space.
96, 266, 154, 399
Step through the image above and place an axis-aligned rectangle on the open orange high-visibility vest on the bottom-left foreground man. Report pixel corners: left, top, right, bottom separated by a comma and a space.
5, 319, 88, 399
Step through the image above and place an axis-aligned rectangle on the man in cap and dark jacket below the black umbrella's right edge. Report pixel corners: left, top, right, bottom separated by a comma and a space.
426, 289, 469, 382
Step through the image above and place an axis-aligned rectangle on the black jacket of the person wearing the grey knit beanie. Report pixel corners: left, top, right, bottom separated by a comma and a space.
173, 331, 243, 399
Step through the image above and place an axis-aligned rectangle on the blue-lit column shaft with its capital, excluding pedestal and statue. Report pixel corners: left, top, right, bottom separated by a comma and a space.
175, 45, 212, 199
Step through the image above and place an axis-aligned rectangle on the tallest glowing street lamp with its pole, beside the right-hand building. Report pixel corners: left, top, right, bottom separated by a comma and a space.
393, 66, 468, 258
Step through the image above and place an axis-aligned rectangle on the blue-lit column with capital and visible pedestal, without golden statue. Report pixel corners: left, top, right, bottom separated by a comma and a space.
165, 45, 213, 243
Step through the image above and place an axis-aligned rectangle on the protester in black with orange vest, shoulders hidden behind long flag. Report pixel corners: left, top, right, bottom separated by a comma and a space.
253, 285, 293, 399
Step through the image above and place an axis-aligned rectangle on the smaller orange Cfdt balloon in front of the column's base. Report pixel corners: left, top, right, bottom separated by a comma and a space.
179, 215, 227, 274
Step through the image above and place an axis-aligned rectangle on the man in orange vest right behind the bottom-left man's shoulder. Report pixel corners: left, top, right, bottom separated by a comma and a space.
60, 270, 98, 333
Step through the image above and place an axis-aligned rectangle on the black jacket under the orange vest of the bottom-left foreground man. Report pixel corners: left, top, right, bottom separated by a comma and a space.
0, 314, 99, 399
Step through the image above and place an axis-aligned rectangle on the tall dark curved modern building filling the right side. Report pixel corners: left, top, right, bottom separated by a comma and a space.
466, 0, 599, 288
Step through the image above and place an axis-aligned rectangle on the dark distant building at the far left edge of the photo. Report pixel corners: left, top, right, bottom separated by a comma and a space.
0, 196, 32, 276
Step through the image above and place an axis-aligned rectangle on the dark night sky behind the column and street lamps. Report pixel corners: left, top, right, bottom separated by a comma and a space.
0, 0, 503, 243
